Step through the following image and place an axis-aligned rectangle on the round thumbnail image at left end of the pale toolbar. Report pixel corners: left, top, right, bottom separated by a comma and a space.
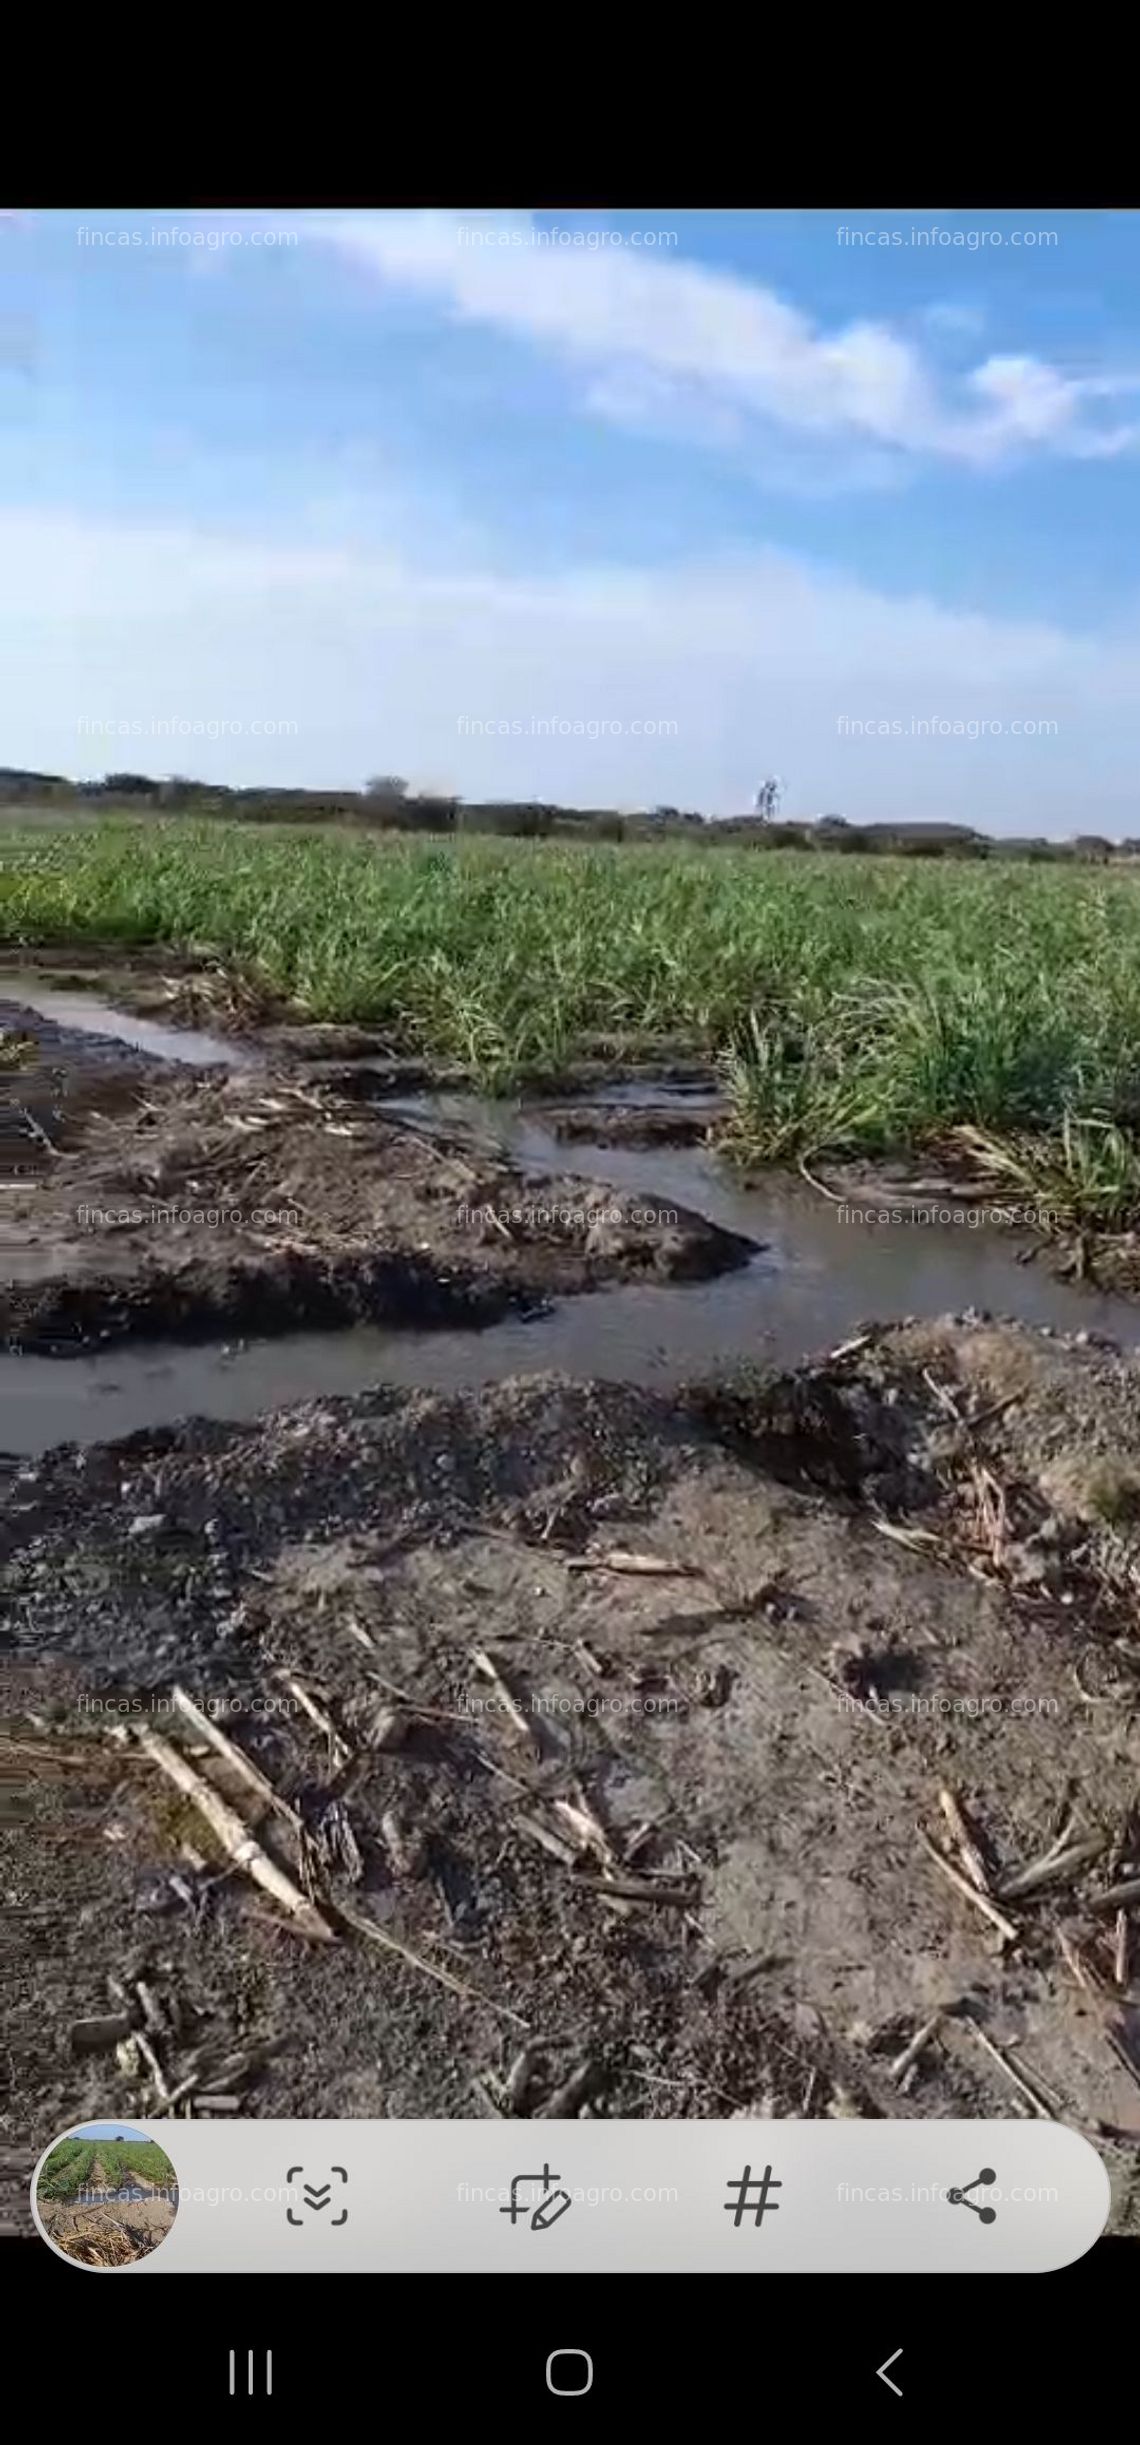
32, 2122, 179, 2269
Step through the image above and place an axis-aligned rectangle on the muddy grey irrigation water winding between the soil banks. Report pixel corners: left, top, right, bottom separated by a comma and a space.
0, 976, 1140, 1455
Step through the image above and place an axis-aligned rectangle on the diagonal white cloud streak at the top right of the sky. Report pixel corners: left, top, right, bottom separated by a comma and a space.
311, 213, 1140, 467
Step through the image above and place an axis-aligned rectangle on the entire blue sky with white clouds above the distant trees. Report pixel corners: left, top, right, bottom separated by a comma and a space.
0, 208, 1140, 836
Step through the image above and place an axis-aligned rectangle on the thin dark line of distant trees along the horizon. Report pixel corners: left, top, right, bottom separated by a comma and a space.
0, 765, 1125, 863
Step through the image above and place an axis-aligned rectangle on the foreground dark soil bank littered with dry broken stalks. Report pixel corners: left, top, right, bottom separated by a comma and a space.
0, 1323, 1140, 2230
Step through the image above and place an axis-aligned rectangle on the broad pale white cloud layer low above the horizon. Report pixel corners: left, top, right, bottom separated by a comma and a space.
0, 511, 1140, 834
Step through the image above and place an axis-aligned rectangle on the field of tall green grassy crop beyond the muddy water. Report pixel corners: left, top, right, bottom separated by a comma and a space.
0, 822, 1140, 1213
